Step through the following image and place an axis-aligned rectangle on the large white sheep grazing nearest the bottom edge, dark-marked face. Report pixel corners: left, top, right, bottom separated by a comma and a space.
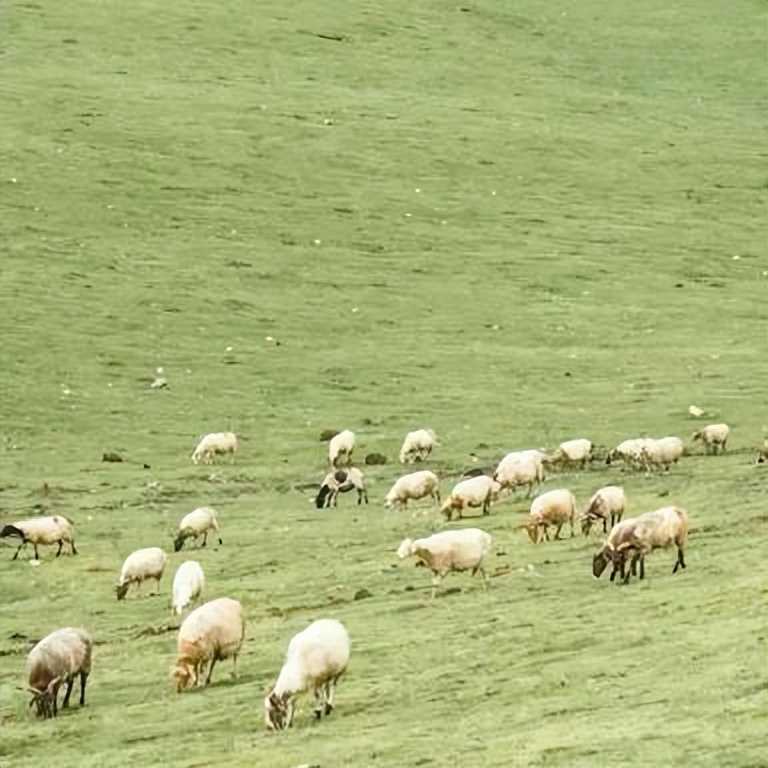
264, 619, 351, 731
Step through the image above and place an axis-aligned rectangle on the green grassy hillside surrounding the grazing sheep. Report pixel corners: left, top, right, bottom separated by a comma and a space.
0, 0, 767, 768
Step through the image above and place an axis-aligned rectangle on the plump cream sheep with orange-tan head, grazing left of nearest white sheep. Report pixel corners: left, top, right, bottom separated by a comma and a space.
170, 597, 245, 693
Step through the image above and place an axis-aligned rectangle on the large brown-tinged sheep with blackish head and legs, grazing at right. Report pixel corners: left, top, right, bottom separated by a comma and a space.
592, 507, 689, 583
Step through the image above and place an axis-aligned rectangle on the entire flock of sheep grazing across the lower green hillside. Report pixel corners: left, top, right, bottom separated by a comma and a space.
0, 424, 744, 730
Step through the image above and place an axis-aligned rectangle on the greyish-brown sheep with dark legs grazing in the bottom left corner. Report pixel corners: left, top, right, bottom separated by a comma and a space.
27, 627, 93, 718
